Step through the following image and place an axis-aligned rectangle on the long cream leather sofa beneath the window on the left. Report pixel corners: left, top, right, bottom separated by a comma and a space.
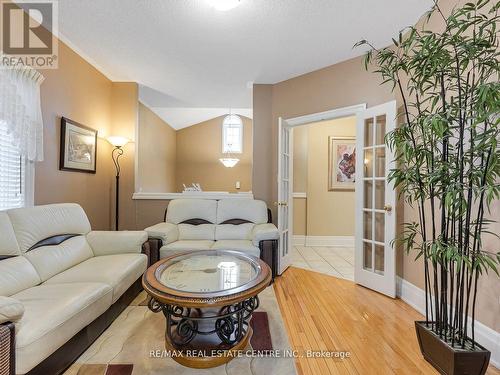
0, 204, 148, 374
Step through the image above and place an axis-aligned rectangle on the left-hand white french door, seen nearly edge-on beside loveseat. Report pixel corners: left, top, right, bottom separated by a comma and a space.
276, 117, 293, 275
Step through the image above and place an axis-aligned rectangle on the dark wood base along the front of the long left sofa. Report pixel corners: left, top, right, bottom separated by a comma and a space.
27, 277, 142, 375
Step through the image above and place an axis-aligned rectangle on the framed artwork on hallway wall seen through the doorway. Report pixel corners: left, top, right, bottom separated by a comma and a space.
328, 137, 356, 191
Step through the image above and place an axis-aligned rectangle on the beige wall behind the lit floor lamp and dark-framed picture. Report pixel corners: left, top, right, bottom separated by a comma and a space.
35, 41, 138, 229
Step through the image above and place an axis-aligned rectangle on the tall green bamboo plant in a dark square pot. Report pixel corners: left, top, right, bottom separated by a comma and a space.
357, 0, 500, 374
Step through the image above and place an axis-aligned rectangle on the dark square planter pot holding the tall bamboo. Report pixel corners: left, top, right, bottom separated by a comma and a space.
415, 322, 491, 375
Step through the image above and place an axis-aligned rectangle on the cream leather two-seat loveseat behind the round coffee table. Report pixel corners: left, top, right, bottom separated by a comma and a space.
145, 199, 279, 266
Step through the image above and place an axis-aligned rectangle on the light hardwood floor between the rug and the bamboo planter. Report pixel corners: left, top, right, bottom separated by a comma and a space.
274, 267, 500, 375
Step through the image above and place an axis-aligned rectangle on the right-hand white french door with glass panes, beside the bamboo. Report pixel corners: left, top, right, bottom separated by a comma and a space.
354, 101, 396, 298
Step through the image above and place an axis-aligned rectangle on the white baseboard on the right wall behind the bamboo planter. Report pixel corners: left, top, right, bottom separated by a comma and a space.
396, 277, 500, 368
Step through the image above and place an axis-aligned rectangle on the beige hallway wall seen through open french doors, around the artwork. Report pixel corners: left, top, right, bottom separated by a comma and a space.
307, 117, 356, 236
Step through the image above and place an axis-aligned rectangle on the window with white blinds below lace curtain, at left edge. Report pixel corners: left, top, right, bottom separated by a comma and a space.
0, 121, 26, 210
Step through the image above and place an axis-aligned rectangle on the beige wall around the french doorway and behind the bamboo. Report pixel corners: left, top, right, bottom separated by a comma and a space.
253, 0, 500, 331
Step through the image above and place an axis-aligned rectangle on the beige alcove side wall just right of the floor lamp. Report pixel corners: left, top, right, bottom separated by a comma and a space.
137, 103, 177, 193
